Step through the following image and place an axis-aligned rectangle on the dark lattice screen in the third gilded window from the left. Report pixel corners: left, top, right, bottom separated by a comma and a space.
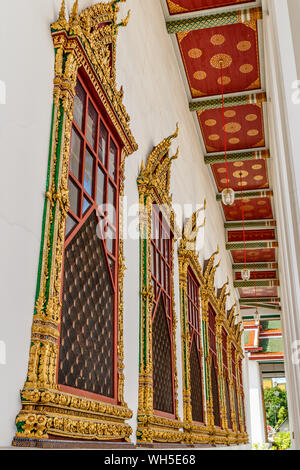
190, 339, 203, 423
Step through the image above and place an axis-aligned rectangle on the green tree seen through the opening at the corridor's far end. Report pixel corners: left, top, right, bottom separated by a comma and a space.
264, 387, 288, 428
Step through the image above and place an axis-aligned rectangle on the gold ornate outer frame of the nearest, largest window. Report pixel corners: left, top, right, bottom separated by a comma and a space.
13, 0, 137, 446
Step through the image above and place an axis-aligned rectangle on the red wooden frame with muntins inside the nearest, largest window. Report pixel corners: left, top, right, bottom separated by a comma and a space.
56, 69, 122, 404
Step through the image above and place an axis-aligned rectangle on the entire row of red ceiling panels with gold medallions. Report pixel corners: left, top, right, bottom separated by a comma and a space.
167, 0, 280, 316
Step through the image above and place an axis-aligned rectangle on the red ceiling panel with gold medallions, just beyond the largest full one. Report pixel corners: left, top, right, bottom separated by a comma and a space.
198, 104, 265, 153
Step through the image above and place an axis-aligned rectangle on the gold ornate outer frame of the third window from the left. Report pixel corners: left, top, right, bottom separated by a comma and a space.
178, 209, 211, 444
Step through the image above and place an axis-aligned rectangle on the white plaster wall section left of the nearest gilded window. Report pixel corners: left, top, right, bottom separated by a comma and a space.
0, 0, 54, 446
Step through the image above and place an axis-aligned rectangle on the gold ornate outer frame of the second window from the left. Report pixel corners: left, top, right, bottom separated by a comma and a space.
137, 125, 183, 445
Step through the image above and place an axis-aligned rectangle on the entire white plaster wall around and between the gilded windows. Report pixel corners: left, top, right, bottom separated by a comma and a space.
0, 0, 239, 446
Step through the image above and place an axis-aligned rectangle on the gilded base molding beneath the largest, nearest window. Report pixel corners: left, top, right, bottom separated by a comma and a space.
15, 389, 132, 442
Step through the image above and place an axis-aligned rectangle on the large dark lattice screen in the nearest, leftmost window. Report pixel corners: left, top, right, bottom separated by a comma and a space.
58, 212, 114, 397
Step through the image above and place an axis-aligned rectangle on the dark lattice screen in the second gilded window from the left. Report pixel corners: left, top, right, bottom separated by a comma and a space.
152, 296, 174, 413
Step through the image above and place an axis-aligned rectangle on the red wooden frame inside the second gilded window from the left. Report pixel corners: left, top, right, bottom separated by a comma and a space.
151, 202, 175, 418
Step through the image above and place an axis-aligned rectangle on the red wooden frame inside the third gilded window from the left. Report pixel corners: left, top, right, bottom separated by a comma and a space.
187, 266, 204, 424
